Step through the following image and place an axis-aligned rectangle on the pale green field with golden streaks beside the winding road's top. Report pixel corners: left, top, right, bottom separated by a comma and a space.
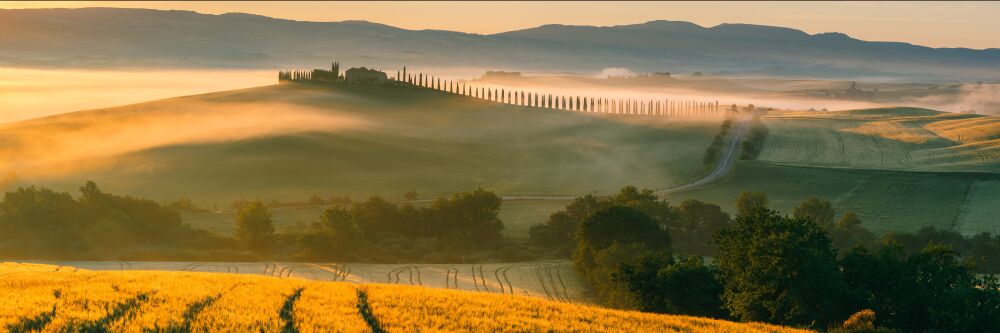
758, 108, 1000, 172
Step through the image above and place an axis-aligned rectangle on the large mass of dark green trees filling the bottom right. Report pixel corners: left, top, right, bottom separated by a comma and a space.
556, 188, 1000, 332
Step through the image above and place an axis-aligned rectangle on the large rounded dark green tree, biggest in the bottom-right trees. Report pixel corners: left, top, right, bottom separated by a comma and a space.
716, 208, 852, 328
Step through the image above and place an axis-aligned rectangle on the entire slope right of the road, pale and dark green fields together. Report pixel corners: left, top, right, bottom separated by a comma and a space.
671, 108, 1000, 234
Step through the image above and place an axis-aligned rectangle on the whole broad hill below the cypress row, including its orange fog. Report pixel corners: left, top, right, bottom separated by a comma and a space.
0, 84, 721, 204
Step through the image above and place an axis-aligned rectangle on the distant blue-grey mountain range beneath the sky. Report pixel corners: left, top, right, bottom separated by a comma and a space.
0, 8, 1000, 81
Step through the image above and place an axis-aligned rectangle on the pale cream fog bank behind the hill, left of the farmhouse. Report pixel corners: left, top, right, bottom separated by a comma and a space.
0, 68, 276, 123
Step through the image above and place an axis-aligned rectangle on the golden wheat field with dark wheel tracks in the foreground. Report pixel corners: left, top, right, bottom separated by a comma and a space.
0, 263, 806, 332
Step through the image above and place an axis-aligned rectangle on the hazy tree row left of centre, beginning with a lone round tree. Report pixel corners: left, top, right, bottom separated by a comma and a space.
236, 189, 506, 262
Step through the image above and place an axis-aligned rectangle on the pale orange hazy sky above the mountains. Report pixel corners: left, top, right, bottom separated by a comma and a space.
0, 1, 1000, 49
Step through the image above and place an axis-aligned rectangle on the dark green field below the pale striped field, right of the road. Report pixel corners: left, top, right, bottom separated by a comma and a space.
668, 162, 1000, 234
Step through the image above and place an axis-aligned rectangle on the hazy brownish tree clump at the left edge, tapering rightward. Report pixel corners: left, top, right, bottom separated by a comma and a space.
0, 182, 241, 259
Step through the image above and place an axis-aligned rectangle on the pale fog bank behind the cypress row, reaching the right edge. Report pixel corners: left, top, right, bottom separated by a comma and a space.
454, 67, 1000, 115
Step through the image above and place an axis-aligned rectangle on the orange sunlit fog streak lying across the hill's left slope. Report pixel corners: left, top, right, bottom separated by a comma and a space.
0, 95, 364, 179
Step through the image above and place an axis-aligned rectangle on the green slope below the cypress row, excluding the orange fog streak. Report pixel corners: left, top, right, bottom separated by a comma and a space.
9, 85, 718, 204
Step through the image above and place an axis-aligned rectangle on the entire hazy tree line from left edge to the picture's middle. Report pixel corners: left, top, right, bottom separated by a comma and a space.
0, 182, 516, 262
